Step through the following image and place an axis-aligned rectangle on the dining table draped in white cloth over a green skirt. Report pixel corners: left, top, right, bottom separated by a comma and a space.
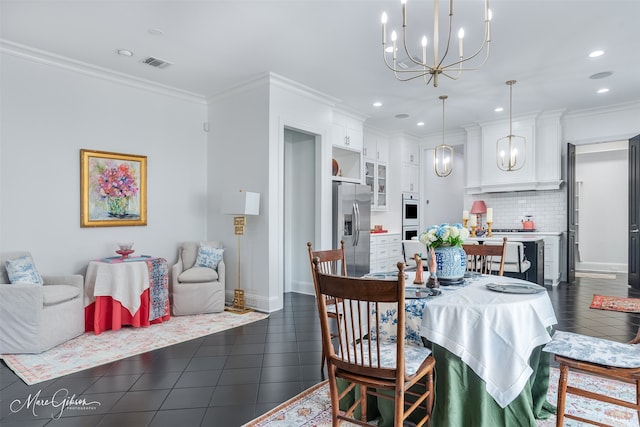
341, 271, 557, 427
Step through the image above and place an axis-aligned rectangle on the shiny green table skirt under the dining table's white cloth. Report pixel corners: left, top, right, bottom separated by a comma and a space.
340, 344, 555, 427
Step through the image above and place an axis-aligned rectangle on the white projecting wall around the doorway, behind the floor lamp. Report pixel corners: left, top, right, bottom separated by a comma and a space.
208, 74, 334, 311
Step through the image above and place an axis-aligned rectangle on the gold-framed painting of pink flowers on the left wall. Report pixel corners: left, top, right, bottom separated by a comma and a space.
80, 149, 147, 227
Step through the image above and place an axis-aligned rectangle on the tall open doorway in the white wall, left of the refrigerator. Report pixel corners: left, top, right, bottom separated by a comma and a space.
283, 128, 319, 294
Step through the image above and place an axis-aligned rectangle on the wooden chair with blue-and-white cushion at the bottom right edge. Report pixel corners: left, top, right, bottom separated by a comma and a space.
542, 328, 640, 427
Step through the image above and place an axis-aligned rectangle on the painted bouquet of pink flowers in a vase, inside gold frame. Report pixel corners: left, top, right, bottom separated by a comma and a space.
98, 163, 138, 218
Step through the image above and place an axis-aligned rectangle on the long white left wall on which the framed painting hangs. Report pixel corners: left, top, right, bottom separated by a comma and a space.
0, 51, 207, 274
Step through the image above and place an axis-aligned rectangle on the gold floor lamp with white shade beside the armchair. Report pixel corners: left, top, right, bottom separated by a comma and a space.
222, 190, 260, 313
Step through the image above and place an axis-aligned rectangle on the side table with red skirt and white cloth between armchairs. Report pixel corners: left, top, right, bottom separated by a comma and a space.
85, 257, 170, 335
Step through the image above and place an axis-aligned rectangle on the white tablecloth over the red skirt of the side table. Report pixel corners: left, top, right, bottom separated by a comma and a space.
84, 261, 149, 316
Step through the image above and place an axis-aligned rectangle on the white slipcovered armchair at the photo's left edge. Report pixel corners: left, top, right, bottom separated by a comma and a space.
0, 252, 84, 354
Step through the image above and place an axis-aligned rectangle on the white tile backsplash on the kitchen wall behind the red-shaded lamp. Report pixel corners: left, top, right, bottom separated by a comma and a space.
464, 189, 567, 232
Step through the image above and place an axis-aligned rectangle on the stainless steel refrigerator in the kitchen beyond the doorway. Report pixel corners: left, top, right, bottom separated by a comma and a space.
333, 182, 371, 277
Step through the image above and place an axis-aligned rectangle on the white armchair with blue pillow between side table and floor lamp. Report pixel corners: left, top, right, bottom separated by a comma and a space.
170, 242, 225, 316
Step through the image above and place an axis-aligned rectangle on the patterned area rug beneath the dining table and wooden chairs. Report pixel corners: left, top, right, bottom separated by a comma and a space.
244, 368, 640, 427
